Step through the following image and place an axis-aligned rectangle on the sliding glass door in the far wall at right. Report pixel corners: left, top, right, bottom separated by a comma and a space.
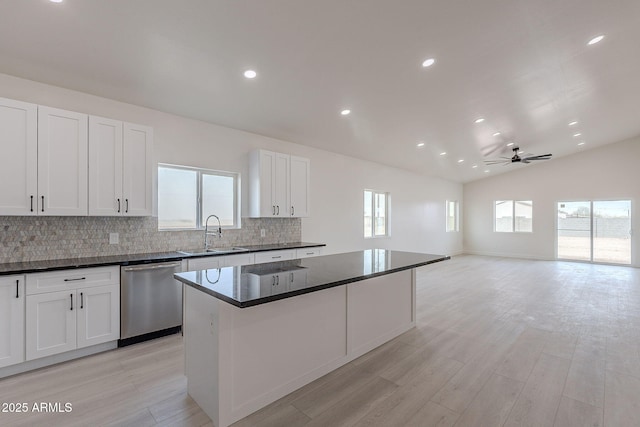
557, 200, 631, 264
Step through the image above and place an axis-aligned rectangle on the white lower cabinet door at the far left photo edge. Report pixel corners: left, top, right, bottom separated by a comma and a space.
0, 276, 25, 368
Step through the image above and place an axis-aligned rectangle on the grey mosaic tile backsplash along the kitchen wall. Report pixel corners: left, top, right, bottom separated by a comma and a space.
0, 216, 302, 263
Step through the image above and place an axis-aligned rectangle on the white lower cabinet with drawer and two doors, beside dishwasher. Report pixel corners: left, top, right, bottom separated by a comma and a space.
25, 267, 120, 360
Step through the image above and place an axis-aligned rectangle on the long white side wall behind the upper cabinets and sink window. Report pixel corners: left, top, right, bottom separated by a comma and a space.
0, 74, 462, 254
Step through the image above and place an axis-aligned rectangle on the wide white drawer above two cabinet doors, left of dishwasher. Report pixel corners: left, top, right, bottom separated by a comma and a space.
26, 266, 120, 295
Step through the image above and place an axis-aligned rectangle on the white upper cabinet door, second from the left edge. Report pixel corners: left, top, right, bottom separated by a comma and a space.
38, 106, 89, 216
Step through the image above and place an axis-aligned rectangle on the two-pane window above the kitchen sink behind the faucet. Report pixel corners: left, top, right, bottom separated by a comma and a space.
158, 164, 240, 230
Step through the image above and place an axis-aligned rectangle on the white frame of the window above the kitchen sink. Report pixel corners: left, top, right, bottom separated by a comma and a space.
158, 163, 242, 231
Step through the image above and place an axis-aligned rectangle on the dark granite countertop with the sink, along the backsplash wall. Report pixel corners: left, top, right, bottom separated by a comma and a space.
0, 242, 325, 276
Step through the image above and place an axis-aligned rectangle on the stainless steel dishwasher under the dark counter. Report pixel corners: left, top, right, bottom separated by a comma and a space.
118, 261, 182, 347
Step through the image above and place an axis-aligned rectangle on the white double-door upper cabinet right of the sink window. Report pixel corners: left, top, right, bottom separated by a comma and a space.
249, 150, 310, 218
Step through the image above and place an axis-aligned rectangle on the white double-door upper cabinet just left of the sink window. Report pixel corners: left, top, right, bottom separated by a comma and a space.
89, 116, 153, 216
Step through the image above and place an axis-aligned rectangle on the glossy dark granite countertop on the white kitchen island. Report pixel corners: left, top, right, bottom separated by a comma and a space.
174, 249, 449, 308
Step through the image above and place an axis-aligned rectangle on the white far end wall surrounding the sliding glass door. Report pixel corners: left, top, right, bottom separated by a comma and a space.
463, 136, 640, 266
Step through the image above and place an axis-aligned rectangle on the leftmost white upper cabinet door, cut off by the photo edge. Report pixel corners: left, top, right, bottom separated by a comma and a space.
0, 98, 38, 215
